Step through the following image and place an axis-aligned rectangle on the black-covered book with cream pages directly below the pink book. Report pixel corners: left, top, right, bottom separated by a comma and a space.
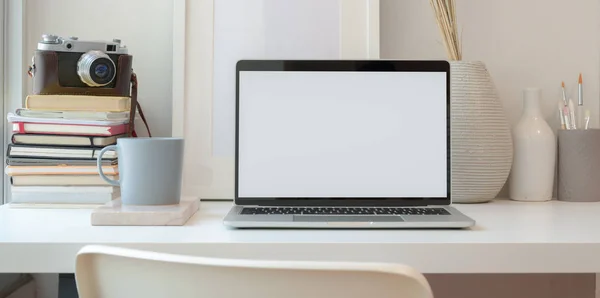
12, 133, 126, 147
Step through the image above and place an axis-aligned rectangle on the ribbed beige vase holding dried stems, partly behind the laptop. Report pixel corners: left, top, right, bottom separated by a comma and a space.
450, 61, 513, 203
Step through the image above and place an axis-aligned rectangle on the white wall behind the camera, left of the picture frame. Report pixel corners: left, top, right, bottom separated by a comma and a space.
26, 0, 173, 136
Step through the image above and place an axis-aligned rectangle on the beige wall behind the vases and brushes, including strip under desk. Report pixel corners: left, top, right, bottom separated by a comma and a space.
380, 0, 600, 298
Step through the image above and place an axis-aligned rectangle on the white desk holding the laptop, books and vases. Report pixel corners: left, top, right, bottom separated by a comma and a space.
0, 201, 600, 273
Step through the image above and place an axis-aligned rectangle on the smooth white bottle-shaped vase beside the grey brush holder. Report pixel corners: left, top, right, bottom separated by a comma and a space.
510, 88, 556, 201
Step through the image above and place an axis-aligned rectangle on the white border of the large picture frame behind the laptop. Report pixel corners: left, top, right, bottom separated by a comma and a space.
172, 0, 380, 201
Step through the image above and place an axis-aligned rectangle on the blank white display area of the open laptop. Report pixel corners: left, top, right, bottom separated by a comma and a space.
237, 71, 448, 198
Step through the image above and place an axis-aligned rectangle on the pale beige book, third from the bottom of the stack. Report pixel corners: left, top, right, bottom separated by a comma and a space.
4, 165, 119, 176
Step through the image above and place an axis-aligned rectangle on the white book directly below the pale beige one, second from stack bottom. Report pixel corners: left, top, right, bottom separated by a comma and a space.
10, 175, 119, 186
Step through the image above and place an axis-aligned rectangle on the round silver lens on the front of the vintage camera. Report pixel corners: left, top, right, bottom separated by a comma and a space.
77, 51, 116, 87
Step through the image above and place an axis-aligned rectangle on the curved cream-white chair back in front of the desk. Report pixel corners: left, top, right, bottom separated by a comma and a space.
75, 245, 433, 298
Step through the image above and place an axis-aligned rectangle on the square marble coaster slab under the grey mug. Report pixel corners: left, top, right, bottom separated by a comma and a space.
92, 197, 200, 226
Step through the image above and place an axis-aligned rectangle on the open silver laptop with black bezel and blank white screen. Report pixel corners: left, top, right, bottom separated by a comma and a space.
224, 60, 475, 228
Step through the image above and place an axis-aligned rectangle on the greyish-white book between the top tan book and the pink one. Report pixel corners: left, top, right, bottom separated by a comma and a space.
15, 109, 129, 121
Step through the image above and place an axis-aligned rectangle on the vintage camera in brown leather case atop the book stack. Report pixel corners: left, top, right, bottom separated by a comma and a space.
30, 34, 133, 96
